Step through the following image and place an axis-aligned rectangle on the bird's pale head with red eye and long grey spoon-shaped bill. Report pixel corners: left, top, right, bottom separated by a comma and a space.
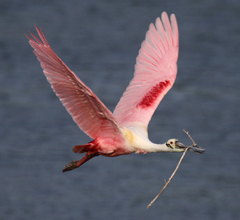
166, 139, 205, 154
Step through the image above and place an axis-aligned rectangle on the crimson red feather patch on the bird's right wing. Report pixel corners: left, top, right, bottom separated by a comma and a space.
137, 80, 170, 108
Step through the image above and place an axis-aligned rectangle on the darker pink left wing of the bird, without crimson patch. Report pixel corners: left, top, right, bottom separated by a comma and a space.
27, 27, 120, 139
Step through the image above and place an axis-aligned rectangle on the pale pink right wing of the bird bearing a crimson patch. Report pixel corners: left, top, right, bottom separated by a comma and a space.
113, 12, 178, 126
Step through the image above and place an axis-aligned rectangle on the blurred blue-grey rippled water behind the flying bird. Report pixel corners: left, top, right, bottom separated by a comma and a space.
0, 0, 240, 220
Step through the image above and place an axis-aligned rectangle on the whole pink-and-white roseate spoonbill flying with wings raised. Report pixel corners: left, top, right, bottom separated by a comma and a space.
26, 12, 204, 172
